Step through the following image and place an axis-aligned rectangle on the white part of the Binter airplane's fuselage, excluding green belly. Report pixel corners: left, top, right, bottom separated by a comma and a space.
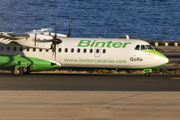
0, 38, 168, 69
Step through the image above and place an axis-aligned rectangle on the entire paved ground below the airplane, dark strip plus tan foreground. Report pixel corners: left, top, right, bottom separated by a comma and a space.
0, 73, 180, 120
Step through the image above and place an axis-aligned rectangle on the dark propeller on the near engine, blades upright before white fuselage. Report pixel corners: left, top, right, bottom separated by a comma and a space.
51, 20, 62, 58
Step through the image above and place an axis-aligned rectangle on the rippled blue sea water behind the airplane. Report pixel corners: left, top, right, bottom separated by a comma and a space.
0, 0, 180, 41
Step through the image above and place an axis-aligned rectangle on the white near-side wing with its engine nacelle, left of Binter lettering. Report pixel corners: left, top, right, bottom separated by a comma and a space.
0, 32, 62, 49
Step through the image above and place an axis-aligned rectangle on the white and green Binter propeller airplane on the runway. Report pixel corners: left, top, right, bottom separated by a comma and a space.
0, 29, 169, 76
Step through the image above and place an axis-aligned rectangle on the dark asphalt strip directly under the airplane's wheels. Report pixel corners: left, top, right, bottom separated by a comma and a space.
0, 73, 180, 91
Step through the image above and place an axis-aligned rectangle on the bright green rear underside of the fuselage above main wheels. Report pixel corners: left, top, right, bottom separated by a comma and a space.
0, 55, 60, 71
